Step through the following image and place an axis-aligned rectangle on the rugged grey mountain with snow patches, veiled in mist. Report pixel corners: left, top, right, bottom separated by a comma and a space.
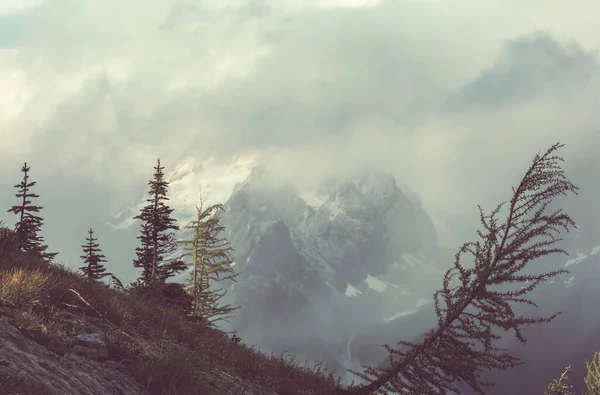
216, 168, 451, 374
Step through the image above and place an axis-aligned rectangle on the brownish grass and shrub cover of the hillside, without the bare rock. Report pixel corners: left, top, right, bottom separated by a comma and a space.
0, 230, 339, 395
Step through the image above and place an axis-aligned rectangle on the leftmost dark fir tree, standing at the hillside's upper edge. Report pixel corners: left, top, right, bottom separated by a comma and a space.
8, 162, 58, 263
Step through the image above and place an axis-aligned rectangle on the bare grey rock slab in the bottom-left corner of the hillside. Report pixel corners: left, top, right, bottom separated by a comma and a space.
0, 305, 144, 395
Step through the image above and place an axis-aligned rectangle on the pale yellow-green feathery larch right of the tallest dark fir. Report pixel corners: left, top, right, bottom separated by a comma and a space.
180, 203, 239, 325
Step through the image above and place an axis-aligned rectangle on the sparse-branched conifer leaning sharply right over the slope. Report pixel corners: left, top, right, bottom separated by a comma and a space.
335, 143, 579, 395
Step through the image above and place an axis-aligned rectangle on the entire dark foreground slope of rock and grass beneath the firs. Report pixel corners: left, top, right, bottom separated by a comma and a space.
0, 234, 338, 395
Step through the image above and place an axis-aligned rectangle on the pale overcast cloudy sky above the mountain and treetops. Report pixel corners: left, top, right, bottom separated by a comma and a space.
0, 0, 600, 276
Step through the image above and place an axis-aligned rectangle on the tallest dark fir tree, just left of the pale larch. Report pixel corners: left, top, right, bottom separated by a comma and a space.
133, 158, 186, 284
